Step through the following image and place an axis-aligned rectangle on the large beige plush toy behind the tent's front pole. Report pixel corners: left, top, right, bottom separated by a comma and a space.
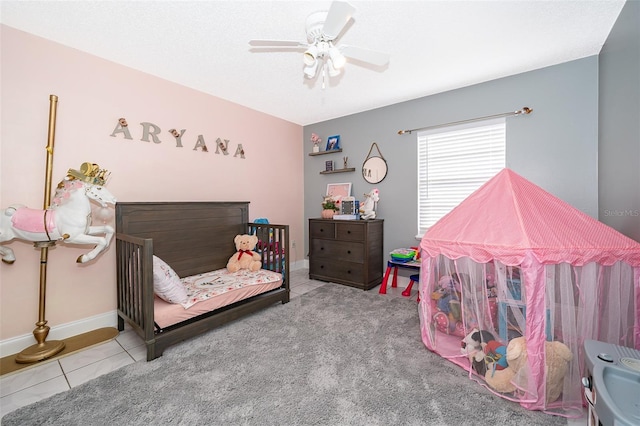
507, 337, 573, 404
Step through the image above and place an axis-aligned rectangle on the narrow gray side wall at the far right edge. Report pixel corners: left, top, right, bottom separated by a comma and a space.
598, 1, 640, 241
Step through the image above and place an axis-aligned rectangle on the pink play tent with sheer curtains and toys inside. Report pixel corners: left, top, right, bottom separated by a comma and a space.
419, 169, 640, 417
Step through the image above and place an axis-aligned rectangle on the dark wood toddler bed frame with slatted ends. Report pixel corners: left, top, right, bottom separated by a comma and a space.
116, 202, 289, 361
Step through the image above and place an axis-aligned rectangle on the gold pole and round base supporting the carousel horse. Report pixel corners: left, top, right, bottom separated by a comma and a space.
16, 95, 64, 364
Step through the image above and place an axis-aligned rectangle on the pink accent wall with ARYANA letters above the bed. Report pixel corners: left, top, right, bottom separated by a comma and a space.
0, 25, 304, 342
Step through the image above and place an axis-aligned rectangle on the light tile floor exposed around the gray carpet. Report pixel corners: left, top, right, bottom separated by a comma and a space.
0, 269, 587, 426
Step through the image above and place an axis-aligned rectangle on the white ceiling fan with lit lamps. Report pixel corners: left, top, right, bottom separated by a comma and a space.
249, 1, 389, 88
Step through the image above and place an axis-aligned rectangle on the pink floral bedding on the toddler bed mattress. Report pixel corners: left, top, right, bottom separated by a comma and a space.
153, 269, 282, 328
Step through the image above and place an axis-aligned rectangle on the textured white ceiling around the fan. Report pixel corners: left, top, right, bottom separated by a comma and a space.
0, 0, 624, 125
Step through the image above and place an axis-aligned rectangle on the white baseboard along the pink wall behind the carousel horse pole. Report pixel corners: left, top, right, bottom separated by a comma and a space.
0, 311, 118, 357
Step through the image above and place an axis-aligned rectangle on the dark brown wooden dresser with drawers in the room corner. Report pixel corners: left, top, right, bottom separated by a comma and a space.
309, 219, 384, 290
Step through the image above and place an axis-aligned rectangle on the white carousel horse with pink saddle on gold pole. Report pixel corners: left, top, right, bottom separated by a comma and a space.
0, 170, 116, 264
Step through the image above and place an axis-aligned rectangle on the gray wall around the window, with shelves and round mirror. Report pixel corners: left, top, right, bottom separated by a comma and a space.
304, 56, 598, 262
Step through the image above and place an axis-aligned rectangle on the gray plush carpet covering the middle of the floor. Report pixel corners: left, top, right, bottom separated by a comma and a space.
2, 284, 566, 426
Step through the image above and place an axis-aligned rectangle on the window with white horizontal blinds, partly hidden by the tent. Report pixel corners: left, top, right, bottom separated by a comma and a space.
418, 118, 506, 236
